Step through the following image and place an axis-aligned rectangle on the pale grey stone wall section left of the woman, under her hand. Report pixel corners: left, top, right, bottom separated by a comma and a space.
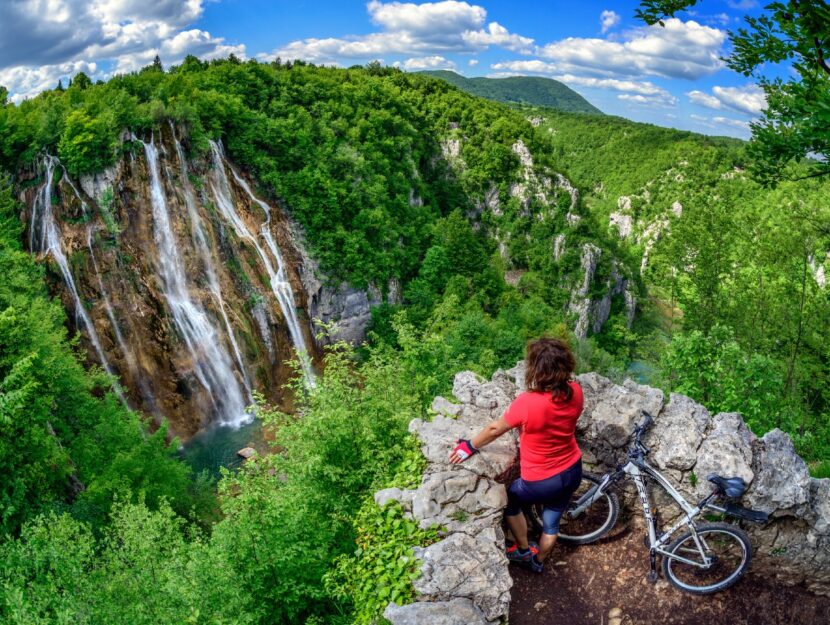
382, 371, 518, 625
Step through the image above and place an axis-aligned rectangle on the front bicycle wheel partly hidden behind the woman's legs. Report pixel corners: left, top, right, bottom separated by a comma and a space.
530, 472, 620, 545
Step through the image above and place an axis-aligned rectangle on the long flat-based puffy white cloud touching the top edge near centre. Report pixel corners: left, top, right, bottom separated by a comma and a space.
270, 0, 533, 62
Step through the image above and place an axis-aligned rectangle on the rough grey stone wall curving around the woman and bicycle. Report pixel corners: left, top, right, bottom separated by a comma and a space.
382, 363, 830, 625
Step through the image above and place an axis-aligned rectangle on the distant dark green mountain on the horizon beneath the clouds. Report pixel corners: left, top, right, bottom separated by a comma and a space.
422, 70, 603, 115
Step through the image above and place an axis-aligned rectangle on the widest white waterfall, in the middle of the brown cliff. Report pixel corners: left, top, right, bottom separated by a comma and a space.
142, 138, 250, 427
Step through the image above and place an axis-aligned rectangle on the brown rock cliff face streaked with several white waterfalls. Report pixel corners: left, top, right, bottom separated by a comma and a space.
20, 125, 379, 438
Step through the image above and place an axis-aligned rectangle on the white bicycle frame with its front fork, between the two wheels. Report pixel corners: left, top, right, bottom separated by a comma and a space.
568, 458, 724, 568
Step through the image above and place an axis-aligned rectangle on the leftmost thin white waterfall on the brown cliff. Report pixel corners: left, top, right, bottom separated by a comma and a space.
29, 156, 127, 405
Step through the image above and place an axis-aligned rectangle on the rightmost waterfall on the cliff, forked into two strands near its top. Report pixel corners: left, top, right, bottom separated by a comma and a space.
210, 141, 315, 386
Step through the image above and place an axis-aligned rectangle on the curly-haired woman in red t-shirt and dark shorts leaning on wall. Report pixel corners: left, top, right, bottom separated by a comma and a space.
450, 338, 583, 573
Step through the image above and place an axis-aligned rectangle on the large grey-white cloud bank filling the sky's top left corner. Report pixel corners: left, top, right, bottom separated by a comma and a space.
0, 0, 245, 102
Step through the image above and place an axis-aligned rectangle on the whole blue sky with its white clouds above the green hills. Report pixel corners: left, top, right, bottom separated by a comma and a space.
0, 0, 764, 137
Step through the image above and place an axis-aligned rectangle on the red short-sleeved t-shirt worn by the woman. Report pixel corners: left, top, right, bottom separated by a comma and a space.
504, 382, 584, 481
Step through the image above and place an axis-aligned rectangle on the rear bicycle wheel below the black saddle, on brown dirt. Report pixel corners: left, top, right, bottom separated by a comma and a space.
663, 523, 752, 595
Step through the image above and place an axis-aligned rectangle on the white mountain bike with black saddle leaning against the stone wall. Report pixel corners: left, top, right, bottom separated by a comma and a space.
525, 411, 768, 595
